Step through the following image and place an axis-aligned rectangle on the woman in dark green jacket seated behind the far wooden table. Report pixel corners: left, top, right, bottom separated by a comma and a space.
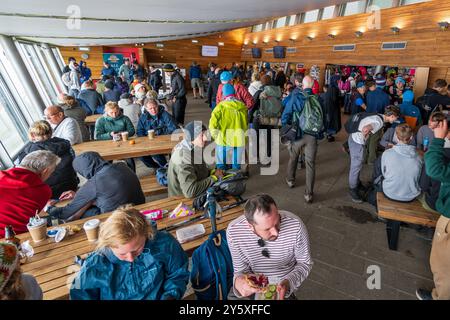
94, 101, 135, 140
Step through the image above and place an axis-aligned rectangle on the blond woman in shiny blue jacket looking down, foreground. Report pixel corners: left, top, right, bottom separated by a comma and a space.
70, 207, 189, 300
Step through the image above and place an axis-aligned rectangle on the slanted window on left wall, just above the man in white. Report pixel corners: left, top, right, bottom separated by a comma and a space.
17, 42, 58, 105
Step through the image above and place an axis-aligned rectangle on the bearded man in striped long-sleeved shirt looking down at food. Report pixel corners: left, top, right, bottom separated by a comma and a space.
227, 194, 313, 300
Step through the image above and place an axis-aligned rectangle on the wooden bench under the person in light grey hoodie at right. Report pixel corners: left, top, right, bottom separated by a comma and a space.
377, 192, 440, 250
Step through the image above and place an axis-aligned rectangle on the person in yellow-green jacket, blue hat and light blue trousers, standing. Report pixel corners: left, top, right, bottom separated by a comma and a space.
209, 83, 248, 170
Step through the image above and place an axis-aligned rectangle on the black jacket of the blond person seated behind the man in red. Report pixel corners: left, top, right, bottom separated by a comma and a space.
18, 137, 78, 199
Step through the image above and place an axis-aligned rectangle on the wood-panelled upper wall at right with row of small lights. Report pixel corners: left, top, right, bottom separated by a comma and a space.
241, 0, 450, 90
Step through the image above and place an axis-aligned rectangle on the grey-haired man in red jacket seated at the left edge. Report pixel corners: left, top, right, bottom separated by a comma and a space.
0, 150, 61, 238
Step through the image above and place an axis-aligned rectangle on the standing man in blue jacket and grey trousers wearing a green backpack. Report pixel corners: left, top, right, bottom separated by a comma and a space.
281, 74, 323, 203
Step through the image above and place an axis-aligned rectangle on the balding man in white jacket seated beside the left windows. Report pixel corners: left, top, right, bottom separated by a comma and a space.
44, 106, 83, 145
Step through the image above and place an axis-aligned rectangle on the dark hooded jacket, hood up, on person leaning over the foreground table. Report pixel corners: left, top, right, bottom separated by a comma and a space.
49, 152, 145, 220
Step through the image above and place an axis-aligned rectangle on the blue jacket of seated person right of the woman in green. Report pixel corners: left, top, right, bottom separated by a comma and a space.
137, 106, 177, 137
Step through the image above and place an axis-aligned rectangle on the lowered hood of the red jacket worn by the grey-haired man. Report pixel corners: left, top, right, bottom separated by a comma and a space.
0, 168, 44, 189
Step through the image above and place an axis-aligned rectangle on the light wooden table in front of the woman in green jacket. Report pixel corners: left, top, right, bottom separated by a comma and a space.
72, 134, 183, 161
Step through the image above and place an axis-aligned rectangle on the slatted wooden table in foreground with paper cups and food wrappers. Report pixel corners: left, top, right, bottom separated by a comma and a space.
10, 197, 243, 300
